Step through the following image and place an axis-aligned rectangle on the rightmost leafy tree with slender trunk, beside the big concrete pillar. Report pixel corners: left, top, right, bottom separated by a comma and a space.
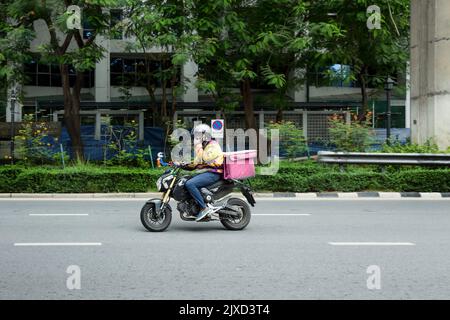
310, 0, 410, 119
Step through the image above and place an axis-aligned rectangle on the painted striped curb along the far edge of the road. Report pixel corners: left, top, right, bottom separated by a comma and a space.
0, 192, 450, 200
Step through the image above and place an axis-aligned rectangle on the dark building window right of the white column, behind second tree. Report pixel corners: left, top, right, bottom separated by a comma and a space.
110, 56, 180, 88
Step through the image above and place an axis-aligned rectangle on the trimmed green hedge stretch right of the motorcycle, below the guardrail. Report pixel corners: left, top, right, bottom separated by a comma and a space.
251, 161, 450, 192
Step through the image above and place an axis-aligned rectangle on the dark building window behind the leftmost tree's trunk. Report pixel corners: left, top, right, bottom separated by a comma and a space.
24, 58, 95, 88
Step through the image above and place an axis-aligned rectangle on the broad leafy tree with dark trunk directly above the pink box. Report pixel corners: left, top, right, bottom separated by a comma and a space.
195, 0, 338, 129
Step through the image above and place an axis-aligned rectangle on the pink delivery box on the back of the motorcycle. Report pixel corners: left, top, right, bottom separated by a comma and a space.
223, 150, 257, 180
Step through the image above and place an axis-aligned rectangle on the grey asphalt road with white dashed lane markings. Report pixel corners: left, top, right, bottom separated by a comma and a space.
0, 199, 450, 299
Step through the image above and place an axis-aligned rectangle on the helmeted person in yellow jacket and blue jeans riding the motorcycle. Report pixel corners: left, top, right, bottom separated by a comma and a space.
185, 124, 223, 221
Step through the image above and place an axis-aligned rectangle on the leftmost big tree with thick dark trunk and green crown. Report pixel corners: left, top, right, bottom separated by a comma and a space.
8, 0, 118, 159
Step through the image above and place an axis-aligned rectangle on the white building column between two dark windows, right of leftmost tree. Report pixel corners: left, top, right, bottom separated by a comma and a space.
95, 36, 111, 102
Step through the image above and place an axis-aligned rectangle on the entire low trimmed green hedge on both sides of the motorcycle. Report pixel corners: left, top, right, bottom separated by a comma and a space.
0, 162, 450, 193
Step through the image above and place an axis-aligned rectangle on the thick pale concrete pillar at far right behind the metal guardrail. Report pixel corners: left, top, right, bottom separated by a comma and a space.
411, 0, 450, 149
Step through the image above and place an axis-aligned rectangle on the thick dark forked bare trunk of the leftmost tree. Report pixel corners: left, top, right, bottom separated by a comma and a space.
60, 65, 84, 161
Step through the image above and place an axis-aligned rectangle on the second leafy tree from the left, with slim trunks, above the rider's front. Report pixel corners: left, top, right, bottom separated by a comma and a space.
118, 0, 196, 123
